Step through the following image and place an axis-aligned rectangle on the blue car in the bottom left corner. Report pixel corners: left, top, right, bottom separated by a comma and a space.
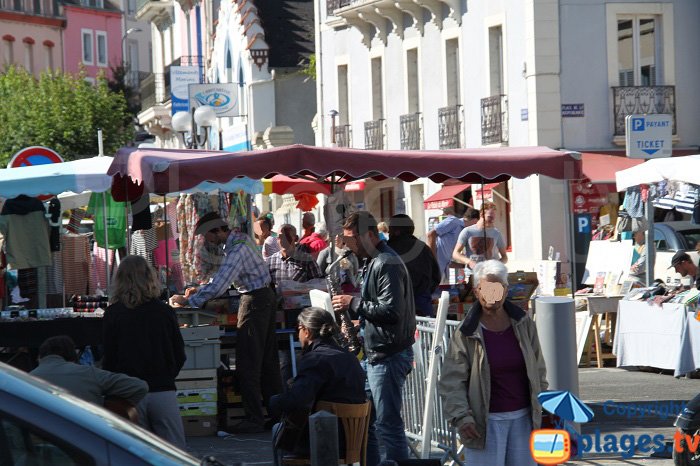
0, 363, 213, 466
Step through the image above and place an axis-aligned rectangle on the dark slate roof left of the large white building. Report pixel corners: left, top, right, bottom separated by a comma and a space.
254, 0, 314, 68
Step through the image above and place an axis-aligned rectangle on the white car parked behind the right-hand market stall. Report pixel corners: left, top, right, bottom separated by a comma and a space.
654, 221, 700, 283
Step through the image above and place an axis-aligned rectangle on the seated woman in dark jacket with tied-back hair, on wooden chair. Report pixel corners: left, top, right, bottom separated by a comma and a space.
269, 307, 366, 464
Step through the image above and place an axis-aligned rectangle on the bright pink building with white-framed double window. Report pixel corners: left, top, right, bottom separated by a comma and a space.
63, 0, 122, 79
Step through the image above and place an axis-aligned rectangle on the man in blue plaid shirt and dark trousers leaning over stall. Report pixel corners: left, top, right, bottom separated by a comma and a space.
170, 212, 282, 433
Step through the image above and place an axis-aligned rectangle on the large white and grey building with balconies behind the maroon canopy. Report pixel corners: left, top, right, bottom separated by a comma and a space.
316, 0, 700, 280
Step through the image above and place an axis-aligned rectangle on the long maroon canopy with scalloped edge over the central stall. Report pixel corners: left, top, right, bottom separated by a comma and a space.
107, 145, 582, 194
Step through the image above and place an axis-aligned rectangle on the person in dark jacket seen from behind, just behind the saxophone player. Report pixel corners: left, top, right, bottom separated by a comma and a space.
387, 214, 442, 317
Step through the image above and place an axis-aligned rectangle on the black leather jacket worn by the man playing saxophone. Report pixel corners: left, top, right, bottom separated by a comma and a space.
350, 241, 416, 363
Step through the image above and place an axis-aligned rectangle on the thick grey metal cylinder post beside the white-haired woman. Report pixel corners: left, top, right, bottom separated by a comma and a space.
535, 296, 578, 396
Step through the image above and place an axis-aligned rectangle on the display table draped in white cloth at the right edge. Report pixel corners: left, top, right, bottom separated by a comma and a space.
613, 301, 700, 377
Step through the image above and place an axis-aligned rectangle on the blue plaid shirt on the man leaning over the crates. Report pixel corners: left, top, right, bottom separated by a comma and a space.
189, 231, 270, 307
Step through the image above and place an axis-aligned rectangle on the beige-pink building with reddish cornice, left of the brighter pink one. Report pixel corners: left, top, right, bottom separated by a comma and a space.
0, 0, 65, 77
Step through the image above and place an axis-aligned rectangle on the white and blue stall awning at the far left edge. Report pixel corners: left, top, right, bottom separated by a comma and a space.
0, 157, 112, 199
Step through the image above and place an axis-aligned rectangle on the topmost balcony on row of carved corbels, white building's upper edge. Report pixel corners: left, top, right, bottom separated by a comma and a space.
326, 0, 462, 47
